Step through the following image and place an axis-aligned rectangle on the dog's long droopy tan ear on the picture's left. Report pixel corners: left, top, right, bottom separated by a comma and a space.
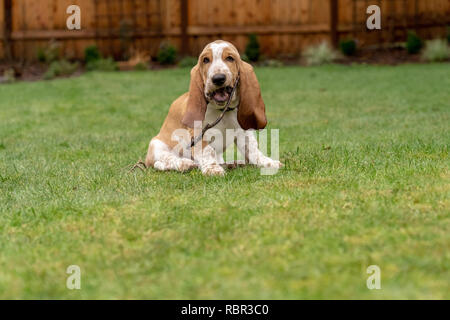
182, 64, 206, 128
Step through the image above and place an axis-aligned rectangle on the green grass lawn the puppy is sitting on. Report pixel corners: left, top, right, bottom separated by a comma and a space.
0, 64, 450, 299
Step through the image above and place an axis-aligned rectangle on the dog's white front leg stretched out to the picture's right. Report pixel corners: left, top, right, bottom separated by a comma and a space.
236, 130, 283, 169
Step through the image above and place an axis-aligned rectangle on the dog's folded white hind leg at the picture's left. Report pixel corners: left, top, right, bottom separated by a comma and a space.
145, 138, 196, 172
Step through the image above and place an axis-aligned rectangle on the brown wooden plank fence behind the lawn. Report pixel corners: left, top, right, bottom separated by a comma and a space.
0, 0, 450, 60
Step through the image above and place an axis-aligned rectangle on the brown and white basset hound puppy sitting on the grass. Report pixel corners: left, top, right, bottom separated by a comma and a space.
145, 40, 281, 175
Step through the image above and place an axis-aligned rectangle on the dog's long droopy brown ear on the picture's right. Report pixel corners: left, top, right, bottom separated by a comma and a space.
238, 61, 267, 130
